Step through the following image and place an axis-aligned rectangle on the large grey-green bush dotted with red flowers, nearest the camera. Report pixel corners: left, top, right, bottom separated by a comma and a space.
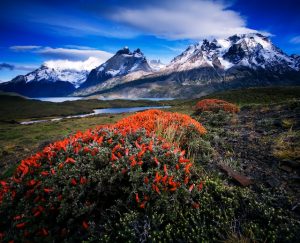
0, 118, 203, 241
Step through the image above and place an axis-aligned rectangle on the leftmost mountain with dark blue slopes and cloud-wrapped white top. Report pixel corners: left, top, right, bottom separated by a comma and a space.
0, 57, 101, 97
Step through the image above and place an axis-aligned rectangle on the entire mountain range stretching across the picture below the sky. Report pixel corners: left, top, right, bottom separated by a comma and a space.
0, 33, 300, 98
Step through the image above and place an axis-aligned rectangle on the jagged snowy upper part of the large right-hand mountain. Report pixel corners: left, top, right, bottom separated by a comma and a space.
167, 33, 298, 71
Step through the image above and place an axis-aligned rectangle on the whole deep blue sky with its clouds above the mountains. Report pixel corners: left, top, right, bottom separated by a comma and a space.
0, 0, 300, 81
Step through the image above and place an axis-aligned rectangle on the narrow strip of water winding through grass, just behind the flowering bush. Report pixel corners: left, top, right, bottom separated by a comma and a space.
20, 106, 171, 125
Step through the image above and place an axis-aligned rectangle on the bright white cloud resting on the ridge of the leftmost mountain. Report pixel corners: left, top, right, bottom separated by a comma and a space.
44, 57, 104, 71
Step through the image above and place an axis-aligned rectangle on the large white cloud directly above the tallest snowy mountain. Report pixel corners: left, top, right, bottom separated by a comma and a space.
110, 0, 257, 39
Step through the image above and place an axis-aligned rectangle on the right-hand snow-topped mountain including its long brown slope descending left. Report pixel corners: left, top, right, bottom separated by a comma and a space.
89, 33, 300, 98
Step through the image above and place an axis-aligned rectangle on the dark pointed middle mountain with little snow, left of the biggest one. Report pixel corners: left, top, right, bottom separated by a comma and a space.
80, 47, 152, 89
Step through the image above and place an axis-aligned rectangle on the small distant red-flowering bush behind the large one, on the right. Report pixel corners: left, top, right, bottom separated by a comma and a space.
194, 99, 239, 113
